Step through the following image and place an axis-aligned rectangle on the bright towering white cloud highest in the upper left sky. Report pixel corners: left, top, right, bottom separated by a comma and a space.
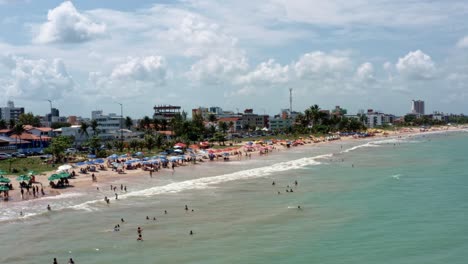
34, 1, 106, 44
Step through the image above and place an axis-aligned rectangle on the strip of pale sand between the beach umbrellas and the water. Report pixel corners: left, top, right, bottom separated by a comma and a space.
1, 126, 466, 207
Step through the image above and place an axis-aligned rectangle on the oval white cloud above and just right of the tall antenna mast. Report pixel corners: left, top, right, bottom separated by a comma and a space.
293, 51, 351, 79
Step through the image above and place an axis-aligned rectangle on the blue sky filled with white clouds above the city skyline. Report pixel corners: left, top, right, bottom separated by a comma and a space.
0, 0, 468, 118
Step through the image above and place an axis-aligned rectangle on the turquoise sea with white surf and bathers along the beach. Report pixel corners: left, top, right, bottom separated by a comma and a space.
0, 132, 468, 264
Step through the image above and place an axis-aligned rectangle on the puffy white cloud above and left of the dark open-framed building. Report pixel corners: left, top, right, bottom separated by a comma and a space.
89, 56, 168, 97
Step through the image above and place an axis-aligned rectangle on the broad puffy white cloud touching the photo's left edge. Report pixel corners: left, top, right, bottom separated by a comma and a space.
2, 56, 75, 99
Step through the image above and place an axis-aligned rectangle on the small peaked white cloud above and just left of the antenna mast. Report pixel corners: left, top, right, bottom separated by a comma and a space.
238, 59, 290, 84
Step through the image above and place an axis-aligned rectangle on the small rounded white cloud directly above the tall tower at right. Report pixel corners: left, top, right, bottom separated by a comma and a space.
396, 50, 436, 80
